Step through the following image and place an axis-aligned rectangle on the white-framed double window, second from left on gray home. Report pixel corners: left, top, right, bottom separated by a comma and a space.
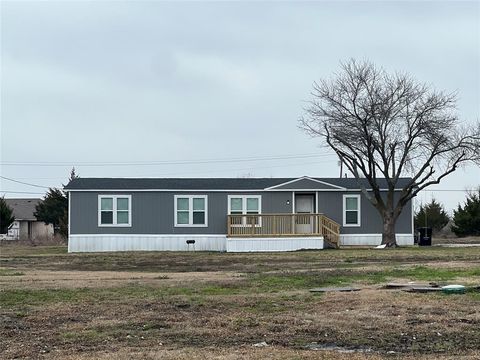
174, 195, 208, 226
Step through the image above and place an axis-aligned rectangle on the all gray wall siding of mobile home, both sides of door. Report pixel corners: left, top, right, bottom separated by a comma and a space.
70, 191, 412, 235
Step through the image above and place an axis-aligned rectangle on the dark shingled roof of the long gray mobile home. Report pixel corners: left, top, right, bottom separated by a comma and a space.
65, 178, 410, 190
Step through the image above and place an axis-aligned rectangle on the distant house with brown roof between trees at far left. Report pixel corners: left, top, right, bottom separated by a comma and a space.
5, 199, 53, 240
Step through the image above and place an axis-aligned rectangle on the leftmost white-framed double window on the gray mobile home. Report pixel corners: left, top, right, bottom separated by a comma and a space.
98, 195, 132, 226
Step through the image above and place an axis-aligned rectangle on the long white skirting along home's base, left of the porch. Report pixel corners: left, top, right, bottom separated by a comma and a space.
68, 234, 226, 252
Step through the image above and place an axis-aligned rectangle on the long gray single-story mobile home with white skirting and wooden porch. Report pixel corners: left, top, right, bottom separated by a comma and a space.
65, 176, 413, 252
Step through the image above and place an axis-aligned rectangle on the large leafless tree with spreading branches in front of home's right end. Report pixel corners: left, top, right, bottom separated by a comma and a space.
300, 60, 480, 247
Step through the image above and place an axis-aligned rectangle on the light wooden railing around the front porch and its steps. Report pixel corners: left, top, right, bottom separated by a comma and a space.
227, 214, 340, 246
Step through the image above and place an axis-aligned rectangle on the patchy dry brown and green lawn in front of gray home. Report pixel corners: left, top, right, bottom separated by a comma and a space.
0, 245, 480, 360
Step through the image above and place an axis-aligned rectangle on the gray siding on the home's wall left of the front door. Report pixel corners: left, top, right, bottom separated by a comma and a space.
70, 191, 292, 235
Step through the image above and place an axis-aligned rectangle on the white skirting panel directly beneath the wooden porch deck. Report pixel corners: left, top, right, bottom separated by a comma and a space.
227, 236, 323, 252
